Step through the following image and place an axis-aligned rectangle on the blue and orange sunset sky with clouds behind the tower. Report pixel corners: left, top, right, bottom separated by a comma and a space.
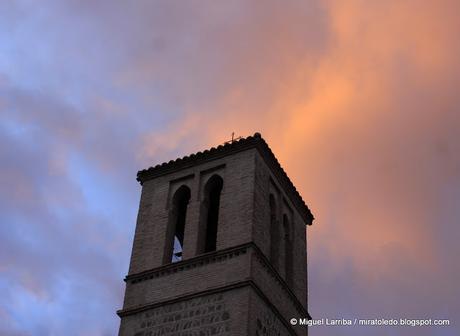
0, 0, 460, 336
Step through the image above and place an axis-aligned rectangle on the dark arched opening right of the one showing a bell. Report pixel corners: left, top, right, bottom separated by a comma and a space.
202, 175, 224, 253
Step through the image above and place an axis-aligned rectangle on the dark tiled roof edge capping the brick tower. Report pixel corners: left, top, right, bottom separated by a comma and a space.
137, 133, 314, 225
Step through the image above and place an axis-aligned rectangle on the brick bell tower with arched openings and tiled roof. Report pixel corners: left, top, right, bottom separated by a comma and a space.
117, 133, 313, 336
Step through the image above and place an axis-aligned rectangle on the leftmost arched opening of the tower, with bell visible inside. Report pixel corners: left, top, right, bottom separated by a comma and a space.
163, 185, 190, 264
